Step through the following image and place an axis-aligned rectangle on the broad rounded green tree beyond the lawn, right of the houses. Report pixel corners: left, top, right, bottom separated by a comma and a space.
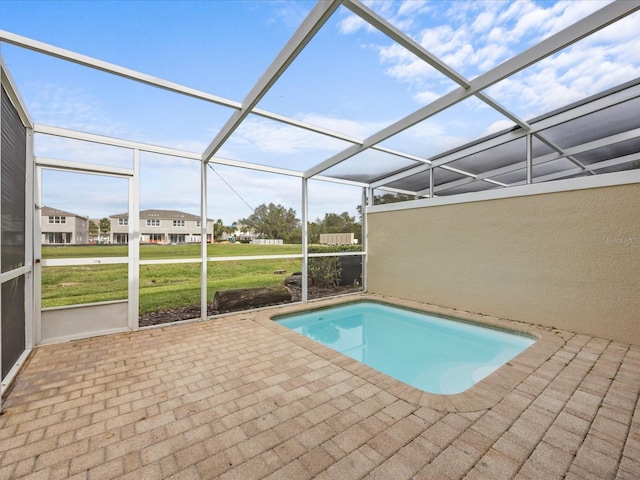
238, 203, 300, 243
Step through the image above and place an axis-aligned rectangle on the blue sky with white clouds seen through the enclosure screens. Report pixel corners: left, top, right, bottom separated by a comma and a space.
0, 0, 640, 224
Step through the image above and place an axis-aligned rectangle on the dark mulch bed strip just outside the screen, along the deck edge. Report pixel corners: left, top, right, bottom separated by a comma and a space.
140, 286, 362, 327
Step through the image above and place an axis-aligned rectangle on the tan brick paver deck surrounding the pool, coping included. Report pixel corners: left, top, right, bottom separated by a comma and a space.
0, 292, 640, 480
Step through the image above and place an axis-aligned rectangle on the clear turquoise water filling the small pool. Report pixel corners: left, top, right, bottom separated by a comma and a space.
275, 302, 535, 394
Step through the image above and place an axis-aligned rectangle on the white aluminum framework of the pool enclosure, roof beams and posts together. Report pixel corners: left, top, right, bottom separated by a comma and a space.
0, 0, 640, 364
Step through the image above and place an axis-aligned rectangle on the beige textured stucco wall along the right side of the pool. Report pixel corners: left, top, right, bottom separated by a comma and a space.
367, 183, 640, 344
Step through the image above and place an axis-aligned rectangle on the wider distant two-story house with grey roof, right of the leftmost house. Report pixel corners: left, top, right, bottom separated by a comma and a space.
109, 210, 213, 244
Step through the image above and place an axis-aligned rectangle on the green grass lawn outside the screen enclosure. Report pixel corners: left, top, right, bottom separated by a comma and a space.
42, 243, 302, 314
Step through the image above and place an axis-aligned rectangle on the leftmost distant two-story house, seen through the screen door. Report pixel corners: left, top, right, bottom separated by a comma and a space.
40, 206, 89, 245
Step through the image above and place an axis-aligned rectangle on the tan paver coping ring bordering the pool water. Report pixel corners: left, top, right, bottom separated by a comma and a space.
254, 293, 565, 413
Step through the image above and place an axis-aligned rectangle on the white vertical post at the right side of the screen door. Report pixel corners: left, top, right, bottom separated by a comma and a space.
128, 148, 140, 331
